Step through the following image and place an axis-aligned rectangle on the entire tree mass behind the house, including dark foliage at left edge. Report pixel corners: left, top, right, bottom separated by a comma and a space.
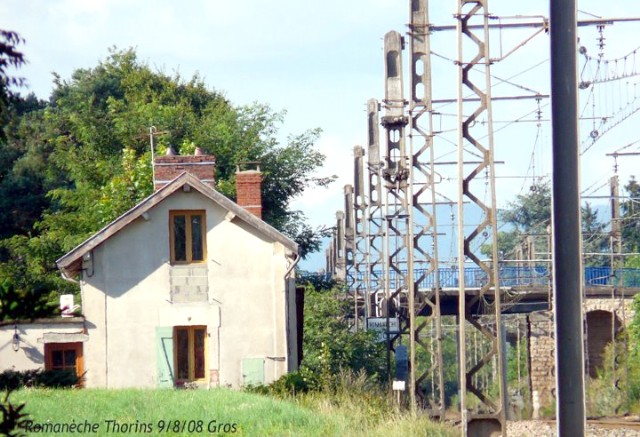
0, 47, 335, 318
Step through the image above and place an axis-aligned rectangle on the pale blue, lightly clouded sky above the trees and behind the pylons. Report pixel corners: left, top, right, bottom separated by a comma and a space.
0, 0, 640, 270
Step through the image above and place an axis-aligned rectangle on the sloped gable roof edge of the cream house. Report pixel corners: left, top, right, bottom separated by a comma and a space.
56, 172, 298, 276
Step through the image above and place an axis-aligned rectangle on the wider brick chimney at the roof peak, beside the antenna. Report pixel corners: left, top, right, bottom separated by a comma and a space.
153, 147, 216, 191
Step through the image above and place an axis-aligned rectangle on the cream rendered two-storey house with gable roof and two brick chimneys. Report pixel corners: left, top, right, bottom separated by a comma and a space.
1, 155, 298, 388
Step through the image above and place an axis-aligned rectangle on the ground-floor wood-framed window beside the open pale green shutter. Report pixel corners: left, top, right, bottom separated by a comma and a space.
173, 326, 207, 382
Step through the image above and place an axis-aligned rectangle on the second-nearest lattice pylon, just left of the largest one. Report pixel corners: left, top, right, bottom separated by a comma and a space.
409, 0, 445, 417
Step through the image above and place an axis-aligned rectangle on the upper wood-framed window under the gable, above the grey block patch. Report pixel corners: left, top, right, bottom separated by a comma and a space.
169, 210, 207, 264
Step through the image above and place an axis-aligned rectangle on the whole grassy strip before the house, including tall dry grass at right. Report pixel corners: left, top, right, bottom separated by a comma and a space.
12, 381, 458, 436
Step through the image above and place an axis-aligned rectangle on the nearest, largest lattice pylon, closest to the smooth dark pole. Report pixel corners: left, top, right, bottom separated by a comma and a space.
456, 0, 506, 435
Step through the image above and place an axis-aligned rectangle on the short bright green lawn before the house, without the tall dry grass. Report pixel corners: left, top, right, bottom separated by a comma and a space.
12, 389, 340, 436
